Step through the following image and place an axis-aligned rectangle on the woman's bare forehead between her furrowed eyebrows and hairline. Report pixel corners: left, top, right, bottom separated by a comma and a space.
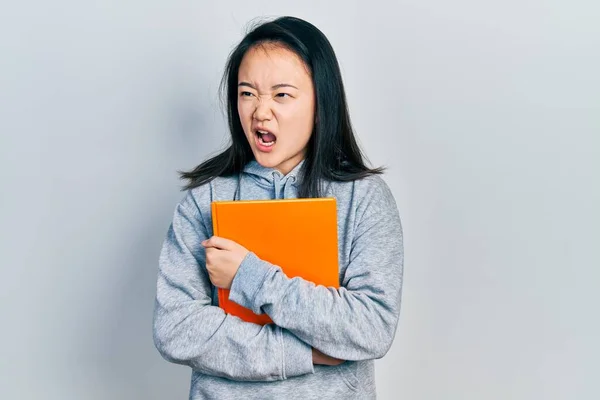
238, 44, 310, 85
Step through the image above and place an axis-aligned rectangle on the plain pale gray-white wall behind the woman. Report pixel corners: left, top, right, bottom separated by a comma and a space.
0, 0, 600, 400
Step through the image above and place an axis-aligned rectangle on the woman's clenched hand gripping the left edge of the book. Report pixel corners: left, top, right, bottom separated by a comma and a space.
202, 236, 248, 289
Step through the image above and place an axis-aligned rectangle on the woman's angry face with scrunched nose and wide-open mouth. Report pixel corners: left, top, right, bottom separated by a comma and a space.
237, 44, 315, 175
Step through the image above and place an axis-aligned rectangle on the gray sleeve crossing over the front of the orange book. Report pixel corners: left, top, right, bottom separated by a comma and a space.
230, 178, 404, 361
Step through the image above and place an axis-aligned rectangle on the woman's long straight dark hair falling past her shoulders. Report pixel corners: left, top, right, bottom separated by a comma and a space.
181, 17, 384, 197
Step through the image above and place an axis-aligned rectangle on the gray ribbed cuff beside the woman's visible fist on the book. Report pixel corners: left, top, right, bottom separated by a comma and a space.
229, 252, 274, 314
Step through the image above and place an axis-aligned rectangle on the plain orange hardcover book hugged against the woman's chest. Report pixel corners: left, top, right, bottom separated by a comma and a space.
211, 198, 339, 325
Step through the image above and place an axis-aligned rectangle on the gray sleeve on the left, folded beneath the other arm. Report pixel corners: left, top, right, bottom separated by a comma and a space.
153, 194, 314, 381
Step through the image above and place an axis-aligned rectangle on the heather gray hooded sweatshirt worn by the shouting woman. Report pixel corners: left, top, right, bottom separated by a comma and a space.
154, 161, 403, 400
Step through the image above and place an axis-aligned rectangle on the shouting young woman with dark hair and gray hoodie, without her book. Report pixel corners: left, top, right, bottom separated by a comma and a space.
154, 17, 403, 399
